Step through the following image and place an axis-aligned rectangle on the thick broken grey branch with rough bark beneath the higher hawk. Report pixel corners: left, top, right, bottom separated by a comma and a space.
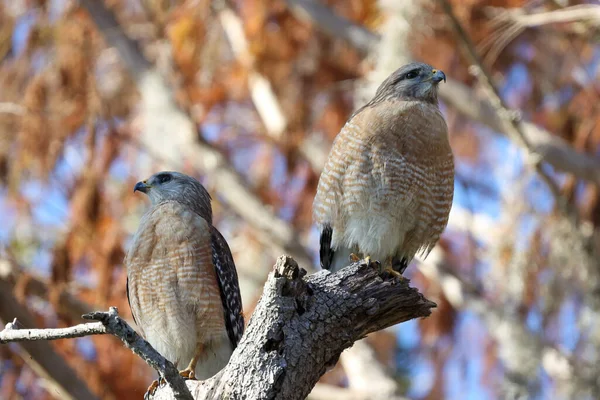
153, 256, 435, 400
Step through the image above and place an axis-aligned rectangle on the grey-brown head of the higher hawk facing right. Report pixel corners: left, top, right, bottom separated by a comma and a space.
373, 62, 446, 104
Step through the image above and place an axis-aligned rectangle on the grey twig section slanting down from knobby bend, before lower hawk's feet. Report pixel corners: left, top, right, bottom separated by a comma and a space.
82, 307, 193, 400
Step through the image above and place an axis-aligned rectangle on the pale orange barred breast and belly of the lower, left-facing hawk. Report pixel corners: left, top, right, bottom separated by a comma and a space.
125, 202, 225, 365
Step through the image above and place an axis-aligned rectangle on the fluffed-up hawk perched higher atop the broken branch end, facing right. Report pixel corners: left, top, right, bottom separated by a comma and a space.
313, 63, 454, 274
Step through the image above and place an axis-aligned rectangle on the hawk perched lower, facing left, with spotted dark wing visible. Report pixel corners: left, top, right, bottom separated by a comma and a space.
125, 172, 244, 392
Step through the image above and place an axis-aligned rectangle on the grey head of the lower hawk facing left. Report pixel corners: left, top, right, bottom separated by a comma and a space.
133, 171, 212, 224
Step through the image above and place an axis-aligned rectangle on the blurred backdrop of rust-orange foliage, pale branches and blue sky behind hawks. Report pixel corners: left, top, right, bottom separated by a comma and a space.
0, 0, 600, 400
